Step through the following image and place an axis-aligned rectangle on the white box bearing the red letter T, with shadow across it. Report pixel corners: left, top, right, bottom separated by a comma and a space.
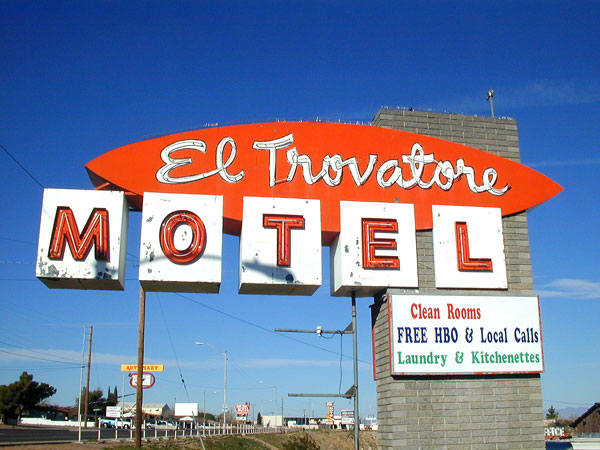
239, 197, 322, 295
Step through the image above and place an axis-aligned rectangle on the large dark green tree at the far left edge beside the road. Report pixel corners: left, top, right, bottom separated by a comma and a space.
0, 372, 56, 423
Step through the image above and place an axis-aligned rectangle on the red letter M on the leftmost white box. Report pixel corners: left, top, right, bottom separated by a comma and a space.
48, 206, 110, 261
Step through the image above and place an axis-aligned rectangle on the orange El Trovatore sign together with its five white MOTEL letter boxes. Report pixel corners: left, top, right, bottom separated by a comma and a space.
36, 123, 561, 296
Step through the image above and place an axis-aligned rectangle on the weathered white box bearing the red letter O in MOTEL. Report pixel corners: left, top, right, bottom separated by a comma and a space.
139, 192, 223, 293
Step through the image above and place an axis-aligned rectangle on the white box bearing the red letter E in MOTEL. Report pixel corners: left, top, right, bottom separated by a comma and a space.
331, 201, 419, 297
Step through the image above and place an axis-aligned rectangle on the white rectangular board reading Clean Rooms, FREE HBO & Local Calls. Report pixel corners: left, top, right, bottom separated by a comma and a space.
388, 295, 544, 375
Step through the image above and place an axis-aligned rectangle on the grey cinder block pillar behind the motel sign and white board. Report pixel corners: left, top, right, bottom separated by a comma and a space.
372, 109, 545, 450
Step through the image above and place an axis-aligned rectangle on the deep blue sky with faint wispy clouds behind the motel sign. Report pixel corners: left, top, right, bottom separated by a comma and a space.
0, 1, 600, 415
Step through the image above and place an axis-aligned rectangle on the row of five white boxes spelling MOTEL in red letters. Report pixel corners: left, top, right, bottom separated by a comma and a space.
37, 189, 506, 296
